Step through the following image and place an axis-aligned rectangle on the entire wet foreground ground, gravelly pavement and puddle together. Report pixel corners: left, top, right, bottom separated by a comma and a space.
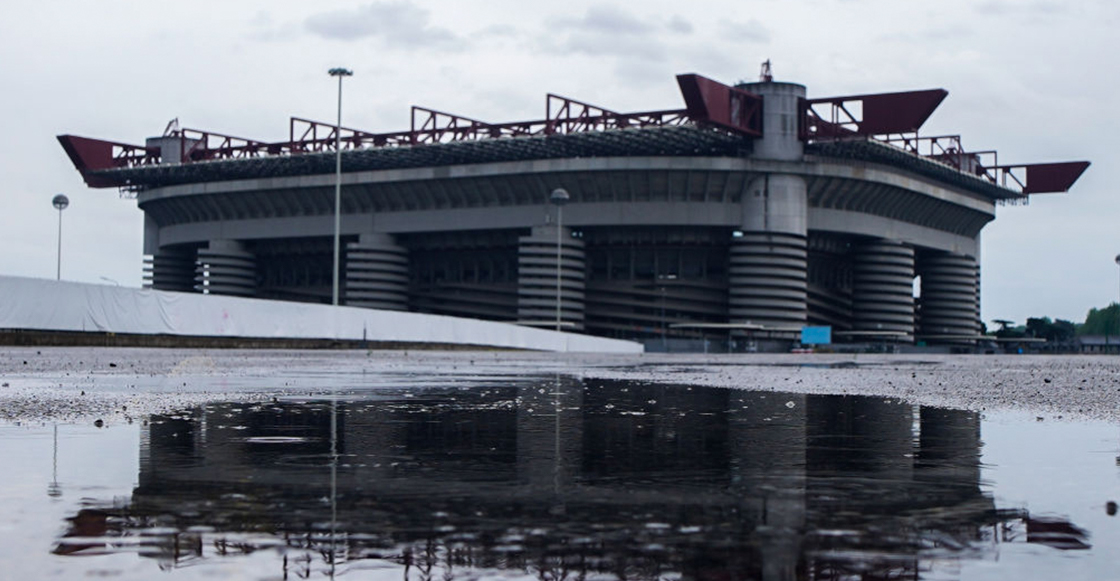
0, 349, 1120, 580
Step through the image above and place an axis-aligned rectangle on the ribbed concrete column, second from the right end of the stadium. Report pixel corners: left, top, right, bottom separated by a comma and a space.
851, 241, 914, 343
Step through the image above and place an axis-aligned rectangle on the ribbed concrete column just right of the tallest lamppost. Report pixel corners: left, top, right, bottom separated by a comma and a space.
343, 234, 409, 311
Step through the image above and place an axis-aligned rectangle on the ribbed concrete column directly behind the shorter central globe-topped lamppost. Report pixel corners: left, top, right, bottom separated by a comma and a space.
517, 225, 587, 330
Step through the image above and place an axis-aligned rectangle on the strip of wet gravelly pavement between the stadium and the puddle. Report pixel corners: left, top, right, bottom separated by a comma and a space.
0, 347, 1120, 424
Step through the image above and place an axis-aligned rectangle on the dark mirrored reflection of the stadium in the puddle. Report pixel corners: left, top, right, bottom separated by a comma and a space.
56, 379, 1088, 580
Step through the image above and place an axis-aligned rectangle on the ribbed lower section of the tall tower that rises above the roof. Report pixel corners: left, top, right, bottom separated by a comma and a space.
728, 232, 809, 329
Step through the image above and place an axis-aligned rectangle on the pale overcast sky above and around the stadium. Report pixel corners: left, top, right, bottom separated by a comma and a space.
0, 0, 1120, 322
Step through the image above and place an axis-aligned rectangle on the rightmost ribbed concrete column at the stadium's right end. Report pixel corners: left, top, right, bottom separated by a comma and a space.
918, 253, 980, 344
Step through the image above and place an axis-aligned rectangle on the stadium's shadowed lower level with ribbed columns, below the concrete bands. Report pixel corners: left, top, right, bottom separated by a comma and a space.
146, 225, 980, 345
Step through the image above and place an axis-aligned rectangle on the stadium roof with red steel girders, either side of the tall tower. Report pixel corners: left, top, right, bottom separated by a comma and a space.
58, 75, 1089, 199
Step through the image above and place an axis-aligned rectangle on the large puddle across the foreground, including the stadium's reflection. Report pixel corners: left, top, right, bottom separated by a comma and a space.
0, 378, 1120, 581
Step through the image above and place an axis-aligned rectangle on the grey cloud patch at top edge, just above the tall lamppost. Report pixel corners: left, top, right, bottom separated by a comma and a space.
305, 0, 461, 49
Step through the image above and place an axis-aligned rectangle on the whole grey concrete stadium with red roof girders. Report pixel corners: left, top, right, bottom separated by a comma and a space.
58, 66, 1089, 348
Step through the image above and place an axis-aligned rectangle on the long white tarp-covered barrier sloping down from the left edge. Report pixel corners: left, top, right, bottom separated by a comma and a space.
0, 277, 642, 353
